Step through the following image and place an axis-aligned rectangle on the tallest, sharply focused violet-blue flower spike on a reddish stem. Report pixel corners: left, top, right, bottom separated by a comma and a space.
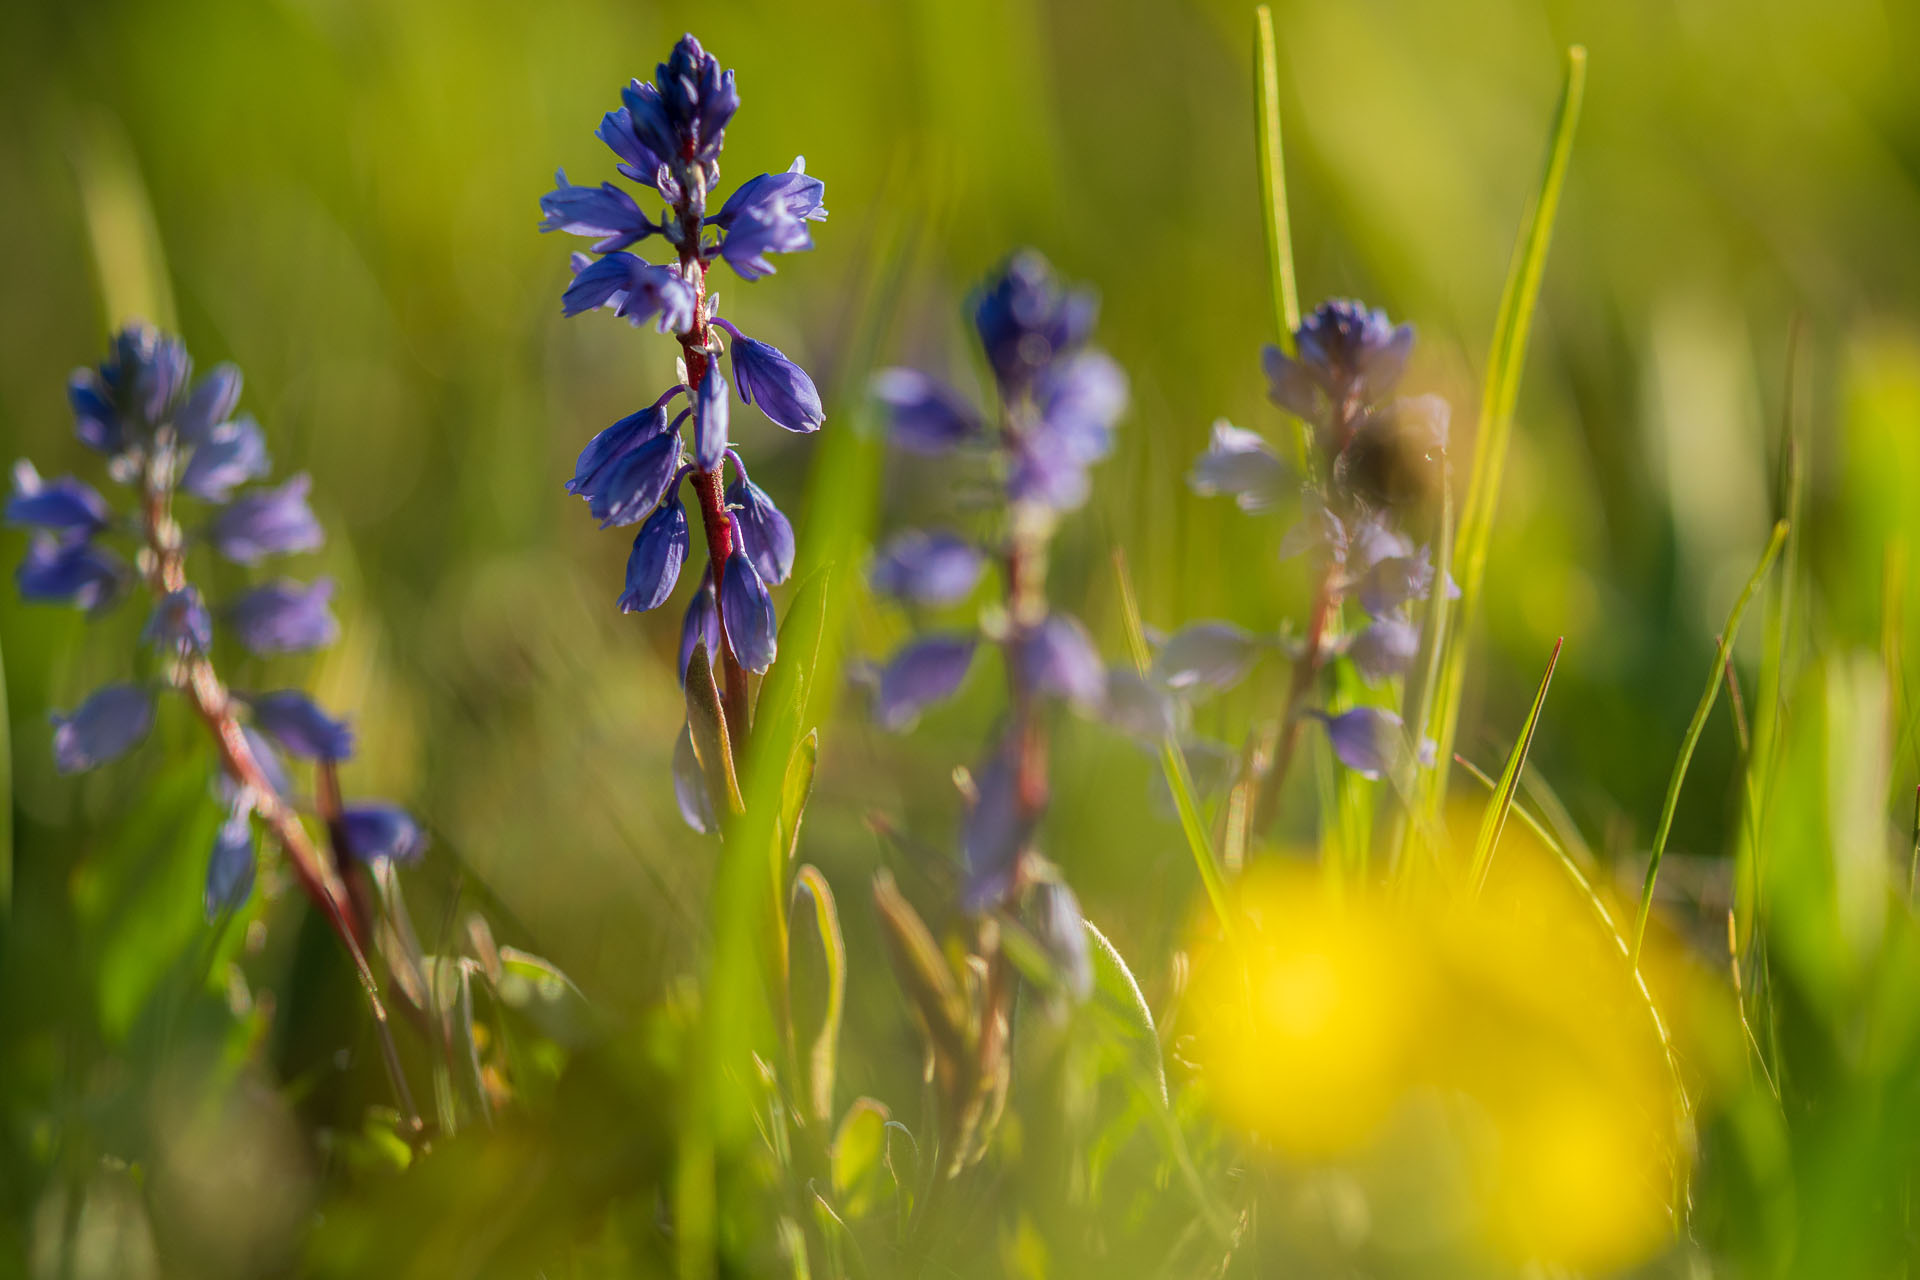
540, 35, 828, 782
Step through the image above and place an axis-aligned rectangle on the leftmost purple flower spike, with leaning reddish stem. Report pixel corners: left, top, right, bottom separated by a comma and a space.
6, 324, 426, 917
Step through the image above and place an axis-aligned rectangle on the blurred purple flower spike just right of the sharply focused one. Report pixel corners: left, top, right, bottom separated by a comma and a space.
870, 251, 1127, 992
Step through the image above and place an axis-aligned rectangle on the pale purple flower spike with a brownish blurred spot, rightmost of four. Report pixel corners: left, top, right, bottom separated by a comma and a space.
1154, 299, 1457, 777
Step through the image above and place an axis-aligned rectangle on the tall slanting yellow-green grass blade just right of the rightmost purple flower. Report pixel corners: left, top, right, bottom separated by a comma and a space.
1423, 44, 1586, 818
